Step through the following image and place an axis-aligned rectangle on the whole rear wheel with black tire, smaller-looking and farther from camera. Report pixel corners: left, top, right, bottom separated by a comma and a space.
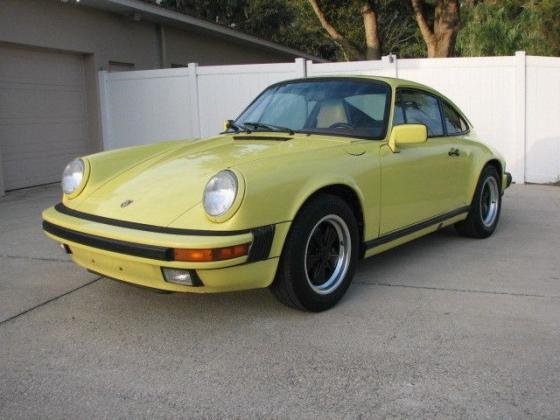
455, 166, 502, 239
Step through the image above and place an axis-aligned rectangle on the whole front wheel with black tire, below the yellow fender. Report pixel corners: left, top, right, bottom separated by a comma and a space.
271, 194, 359, 312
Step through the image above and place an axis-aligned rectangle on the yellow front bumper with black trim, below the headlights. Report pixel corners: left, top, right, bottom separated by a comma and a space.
43, 204, 289, 293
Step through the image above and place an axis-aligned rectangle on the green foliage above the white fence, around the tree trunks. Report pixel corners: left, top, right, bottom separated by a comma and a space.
154, 0, 560, 60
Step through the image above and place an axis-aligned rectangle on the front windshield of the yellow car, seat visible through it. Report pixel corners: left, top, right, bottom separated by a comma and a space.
235, 79, 390, 139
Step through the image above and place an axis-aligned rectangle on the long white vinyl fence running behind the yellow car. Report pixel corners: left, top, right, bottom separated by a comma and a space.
99, 52, 560, 183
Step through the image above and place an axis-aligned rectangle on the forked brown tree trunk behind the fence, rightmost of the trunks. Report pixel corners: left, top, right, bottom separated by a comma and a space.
411, 0, 460, 57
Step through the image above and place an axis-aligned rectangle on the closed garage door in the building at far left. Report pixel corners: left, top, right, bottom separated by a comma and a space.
0, 46, 88, 190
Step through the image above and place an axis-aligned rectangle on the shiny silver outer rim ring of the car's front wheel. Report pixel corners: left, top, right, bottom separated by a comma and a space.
303, 214, 352, 295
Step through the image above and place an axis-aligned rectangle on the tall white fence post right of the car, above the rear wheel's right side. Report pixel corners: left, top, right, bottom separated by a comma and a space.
515, 51, 527, 183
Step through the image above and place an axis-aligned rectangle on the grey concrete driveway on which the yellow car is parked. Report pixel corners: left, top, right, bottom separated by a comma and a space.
0, 185, 560, 418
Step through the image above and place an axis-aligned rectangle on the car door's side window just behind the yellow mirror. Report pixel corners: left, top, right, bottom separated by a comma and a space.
399, 91, 443, 137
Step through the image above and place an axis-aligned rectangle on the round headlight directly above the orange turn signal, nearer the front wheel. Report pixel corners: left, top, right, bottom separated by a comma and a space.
202, 170, 238, 217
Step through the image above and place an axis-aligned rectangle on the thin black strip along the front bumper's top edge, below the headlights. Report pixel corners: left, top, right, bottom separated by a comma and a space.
54, 203, 258, 236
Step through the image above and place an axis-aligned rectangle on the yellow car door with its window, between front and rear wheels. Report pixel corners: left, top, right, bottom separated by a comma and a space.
380, 89, 461, 235
